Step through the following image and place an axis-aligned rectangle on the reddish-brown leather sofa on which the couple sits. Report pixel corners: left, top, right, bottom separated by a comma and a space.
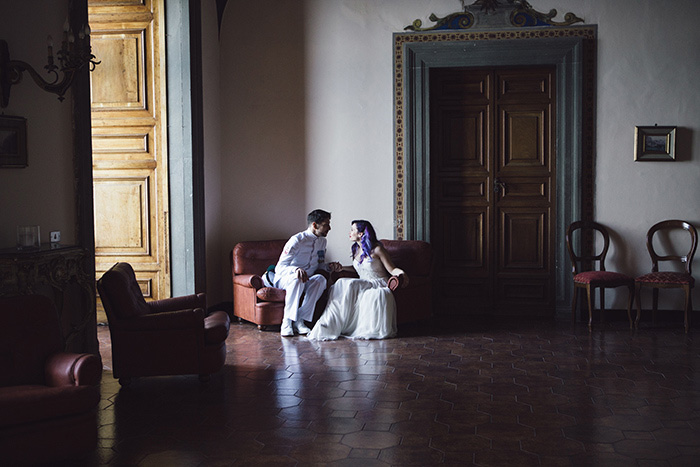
230, 240, 433, 329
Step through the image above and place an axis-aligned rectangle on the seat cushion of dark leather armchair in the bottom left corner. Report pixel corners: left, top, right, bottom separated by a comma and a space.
0, 385, 100, 428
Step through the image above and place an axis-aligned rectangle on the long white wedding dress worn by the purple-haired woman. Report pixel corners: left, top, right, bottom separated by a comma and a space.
307, 258, 396, 340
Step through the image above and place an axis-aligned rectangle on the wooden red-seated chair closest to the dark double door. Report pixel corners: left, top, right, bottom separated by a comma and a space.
566, 221, 634, 329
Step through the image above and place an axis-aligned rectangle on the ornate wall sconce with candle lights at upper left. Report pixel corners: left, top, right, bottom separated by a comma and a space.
0, 20, 101, 108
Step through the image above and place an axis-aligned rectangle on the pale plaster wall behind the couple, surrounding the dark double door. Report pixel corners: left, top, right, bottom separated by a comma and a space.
213, 0, 700, 308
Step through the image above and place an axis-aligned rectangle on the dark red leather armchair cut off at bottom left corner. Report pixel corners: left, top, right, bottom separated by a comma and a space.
0, 295, 102, 465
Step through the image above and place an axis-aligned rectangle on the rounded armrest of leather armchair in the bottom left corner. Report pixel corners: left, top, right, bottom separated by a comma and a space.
44, 352, 102, 386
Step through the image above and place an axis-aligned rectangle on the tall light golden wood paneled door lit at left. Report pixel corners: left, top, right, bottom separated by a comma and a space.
88, 0, 170, 320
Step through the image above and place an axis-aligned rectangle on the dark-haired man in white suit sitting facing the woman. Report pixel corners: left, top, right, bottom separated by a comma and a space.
273, 209, 342, 337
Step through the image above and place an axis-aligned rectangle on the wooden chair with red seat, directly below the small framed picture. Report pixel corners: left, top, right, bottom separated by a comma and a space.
634, 220, 698, 332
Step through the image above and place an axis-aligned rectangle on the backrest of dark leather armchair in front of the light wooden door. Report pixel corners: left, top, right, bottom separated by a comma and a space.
97, 263, 150, 323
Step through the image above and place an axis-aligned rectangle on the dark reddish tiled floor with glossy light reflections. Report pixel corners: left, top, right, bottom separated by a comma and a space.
82, 320, 700, 467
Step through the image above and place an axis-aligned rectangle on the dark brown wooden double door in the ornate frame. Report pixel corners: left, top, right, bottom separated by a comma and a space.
430, 66, 556, 316
